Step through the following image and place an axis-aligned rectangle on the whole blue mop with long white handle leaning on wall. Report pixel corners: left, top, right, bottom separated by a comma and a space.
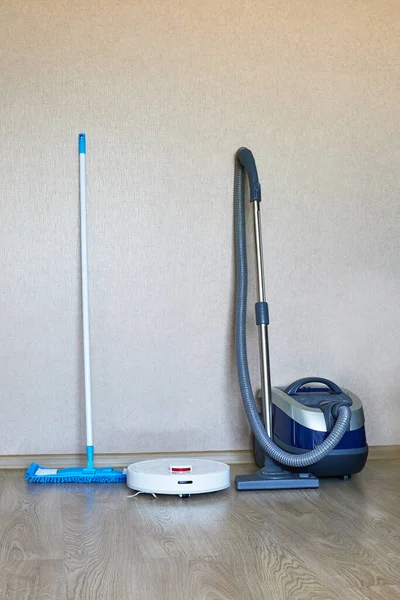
25, 133, 126, 483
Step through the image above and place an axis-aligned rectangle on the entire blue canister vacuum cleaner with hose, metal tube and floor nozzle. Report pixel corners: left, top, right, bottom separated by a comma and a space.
234, 148, 368, 490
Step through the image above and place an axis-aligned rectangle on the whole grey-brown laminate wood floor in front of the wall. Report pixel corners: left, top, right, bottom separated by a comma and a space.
0, 460, 400, 600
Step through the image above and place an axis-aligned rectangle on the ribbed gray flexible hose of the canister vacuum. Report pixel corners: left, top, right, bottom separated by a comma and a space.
234, 157, 351, 467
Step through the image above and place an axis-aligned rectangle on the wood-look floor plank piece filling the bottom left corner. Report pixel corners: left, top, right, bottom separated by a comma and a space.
0, 560, 66, 600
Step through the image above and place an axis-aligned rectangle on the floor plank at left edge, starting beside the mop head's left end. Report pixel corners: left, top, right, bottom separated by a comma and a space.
0, 471, 64, 563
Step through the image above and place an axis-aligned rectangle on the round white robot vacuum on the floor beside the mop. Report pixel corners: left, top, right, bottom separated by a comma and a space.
126, 457, 231, 498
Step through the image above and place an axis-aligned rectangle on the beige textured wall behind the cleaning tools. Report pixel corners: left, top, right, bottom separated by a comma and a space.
0, 0, 400, 454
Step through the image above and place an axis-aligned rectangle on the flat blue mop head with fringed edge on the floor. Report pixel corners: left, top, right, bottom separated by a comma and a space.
25, 463, 126, 483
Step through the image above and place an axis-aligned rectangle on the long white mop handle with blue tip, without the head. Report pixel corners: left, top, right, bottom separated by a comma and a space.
79, 133, 93, 448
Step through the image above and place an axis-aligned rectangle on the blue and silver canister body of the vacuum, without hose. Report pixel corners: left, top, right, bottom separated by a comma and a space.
254, 377, 368, 477
